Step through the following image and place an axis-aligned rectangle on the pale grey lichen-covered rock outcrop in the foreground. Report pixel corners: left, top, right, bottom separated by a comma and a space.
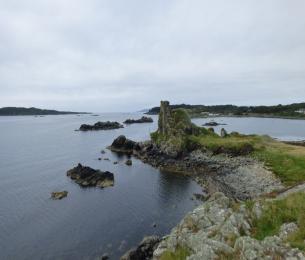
154, 193, 305, 260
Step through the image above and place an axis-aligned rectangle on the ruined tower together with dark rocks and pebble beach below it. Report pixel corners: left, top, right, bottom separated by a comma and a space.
108, 102, 283, 200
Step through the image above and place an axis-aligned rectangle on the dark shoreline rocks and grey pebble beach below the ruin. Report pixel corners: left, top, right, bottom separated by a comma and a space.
108, 136, 283, 200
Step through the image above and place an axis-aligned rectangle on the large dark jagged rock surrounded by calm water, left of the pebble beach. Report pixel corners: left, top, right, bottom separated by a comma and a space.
67, 163, 114, 188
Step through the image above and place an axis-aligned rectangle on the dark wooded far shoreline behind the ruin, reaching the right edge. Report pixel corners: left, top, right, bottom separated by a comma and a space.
147, 103, 305, 119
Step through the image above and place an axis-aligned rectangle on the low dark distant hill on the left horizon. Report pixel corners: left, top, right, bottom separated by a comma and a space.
0, 107, 88, 116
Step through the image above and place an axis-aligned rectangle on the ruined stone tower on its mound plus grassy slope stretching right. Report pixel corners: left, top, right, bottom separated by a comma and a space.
151, 102, 305, 186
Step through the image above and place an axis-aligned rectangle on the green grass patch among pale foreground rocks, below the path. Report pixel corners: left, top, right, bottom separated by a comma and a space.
252, 193, 305, 250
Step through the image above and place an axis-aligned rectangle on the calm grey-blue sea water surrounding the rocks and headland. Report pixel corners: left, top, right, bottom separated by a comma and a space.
0, 114, 305, 259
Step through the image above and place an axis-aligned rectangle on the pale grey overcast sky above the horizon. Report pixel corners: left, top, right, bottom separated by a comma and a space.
0, 0, 305, 112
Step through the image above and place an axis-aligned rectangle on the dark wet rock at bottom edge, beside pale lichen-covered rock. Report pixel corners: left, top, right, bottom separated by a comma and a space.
121, 236, 160, 260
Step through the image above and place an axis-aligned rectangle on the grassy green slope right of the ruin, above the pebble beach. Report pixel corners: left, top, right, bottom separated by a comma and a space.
188, 133, 305, 185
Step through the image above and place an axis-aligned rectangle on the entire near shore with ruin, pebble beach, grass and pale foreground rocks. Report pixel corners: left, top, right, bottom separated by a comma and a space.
108, 101, 305, 260
